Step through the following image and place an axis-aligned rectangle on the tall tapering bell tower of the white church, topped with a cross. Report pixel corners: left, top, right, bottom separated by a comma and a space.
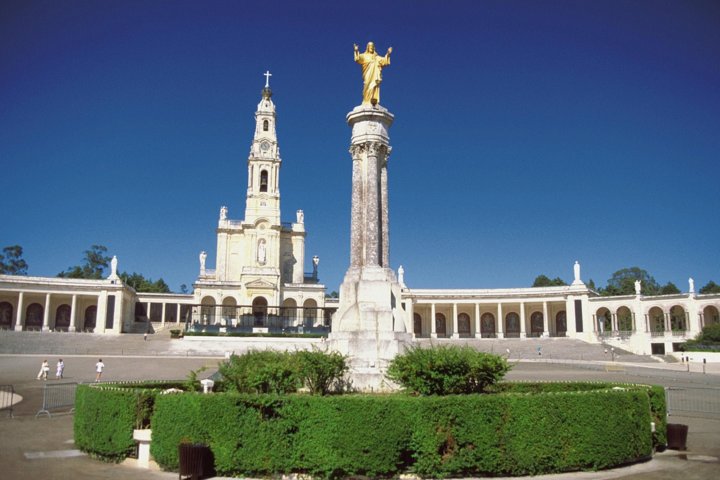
245, 72, 282, 225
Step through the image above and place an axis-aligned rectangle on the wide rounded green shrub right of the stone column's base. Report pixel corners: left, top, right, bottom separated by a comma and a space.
387, 346, 511, 395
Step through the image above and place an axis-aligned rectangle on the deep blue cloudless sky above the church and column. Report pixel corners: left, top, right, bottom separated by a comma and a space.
0, 0, 720, 291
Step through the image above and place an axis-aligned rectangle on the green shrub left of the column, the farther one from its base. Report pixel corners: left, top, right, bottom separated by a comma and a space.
218, 350, 302, 394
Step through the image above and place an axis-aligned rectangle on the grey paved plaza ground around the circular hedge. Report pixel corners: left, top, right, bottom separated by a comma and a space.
0, 335, 720, 480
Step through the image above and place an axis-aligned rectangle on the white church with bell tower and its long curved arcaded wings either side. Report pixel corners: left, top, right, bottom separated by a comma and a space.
0, 82, 720, 354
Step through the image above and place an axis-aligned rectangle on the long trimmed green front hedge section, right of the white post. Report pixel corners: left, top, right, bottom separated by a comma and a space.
151, 385, 653, 478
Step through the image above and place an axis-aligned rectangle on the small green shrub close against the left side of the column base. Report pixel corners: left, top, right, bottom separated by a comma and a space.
294, 350, 348, 395
